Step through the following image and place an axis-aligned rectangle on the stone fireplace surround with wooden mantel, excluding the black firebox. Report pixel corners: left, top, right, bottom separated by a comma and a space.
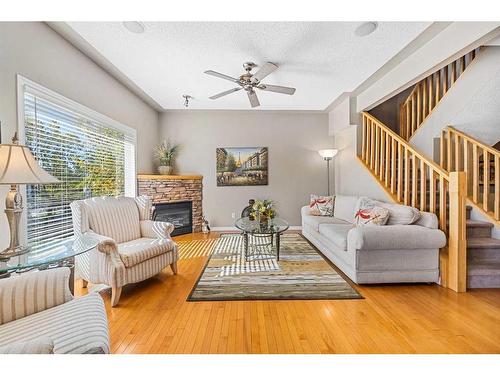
137, 174, 203, 232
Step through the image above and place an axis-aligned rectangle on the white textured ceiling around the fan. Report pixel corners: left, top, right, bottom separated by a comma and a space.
62, 22, 430, 110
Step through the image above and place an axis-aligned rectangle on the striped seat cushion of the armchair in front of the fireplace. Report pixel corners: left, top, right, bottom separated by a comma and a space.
118, 237, 175, 268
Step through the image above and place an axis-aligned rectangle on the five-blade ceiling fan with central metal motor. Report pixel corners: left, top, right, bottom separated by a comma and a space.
205, 62, 295, 108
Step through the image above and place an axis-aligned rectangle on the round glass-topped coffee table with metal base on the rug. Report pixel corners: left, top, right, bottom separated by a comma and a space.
235, 217, 290, 260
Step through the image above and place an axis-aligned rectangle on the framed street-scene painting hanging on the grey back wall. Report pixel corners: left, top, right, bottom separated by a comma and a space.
217, 147, 268, 186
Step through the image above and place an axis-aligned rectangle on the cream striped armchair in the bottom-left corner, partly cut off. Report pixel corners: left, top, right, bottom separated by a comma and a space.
0, 267, 109, 354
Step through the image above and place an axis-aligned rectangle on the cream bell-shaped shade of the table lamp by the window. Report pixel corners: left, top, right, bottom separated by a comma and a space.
0, 144, 60, 185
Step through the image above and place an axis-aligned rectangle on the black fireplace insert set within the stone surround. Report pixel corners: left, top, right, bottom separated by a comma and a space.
153, 201, 193, 236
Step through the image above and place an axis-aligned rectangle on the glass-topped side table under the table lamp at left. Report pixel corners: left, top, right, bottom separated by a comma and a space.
0, 238, 97, 293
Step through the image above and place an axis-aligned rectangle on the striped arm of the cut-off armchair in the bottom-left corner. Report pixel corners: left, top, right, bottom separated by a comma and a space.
0, 293, 109, 354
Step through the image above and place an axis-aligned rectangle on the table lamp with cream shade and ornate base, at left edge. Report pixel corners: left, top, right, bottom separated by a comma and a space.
0, 133, 60, 260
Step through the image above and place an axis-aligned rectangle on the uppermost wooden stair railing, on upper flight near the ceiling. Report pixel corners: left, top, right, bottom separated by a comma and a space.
399, 49, 479, 140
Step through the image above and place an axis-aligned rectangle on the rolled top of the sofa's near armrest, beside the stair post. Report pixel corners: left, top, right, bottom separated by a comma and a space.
347, 225, 446, 250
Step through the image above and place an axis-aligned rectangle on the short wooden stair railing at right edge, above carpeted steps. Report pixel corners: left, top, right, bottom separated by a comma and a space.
440, 126, 500, 221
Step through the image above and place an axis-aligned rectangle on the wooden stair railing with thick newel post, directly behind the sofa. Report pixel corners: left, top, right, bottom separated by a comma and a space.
360, 112, 466, 292
